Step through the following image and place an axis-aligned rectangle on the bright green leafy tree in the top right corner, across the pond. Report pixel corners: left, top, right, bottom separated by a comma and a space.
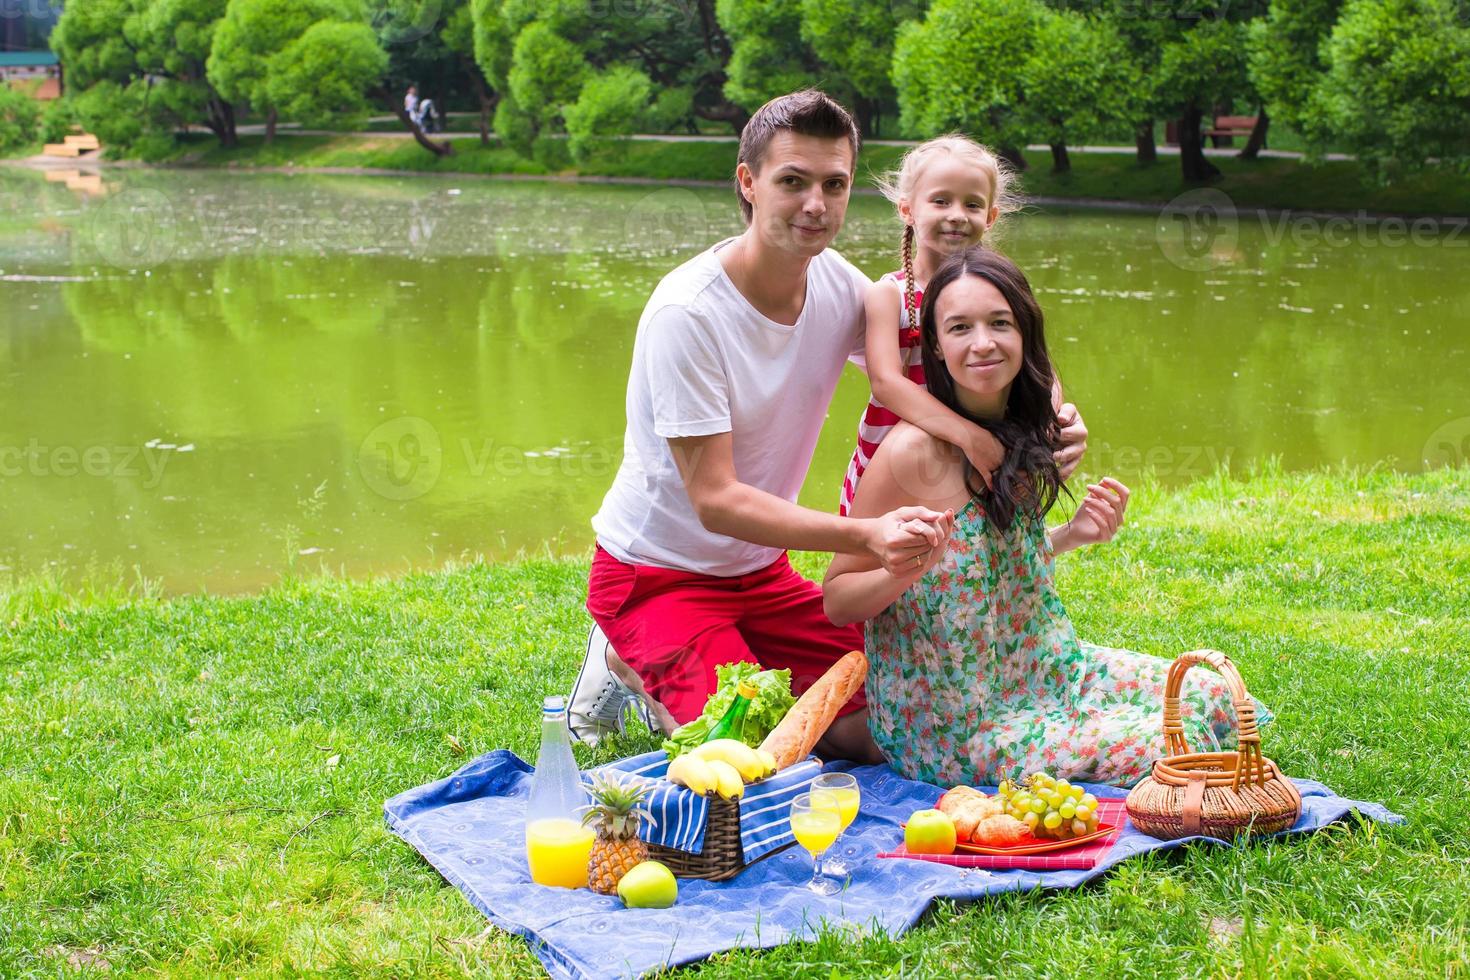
1302, 0, 1470, 178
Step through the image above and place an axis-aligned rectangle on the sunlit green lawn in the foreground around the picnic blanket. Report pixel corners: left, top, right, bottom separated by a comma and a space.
0, 469, 1470, 977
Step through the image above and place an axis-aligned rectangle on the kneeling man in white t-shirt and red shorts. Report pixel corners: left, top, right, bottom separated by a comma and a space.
569, 91, 1085, 761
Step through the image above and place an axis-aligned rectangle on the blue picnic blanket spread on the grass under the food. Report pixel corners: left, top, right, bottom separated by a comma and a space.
384, 749, 1402, 980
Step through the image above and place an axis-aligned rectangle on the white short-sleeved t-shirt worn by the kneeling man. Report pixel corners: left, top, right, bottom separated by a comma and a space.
592, 239, 870, 576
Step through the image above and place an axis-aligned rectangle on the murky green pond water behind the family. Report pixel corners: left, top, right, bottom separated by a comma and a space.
0, 169, 1470, 592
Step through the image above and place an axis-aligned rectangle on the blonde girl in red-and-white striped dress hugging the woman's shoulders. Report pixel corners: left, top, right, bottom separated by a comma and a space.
838, 135, 1014, 516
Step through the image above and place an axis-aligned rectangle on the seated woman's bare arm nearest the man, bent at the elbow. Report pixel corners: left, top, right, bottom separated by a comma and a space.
822, 425, 969, 626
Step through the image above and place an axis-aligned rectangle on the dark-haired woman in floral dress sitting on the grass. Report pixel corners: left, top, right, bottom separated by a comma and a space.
823, 248, 1266, 786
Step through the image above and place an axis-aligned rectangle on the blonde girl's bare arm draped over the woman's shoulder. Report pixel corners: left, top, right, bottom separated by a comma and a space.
866, 279, 1005, 485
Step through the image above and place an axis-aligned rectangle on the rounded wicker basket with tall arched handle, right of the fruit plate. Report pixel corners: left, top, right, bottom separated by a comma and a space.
1127, 649, 1301, 840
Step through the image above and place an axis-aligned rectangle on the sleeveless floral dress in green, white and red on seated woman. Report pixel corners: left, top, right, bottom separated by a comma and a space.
867, 500, 1270, 786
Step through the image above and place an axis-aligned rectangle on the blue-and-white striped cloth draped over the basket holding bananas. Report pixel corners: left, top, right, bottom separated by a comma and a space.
582, 749, 822, 864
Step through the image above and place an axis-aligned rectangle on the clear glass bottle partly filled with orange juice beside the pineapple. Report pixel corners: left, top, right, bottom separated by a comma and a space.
526, 696, 597, 887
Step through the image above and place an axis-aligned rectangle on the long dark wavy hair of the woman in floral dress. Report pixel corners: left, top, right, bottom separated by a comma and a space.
919, 245, 1063, 530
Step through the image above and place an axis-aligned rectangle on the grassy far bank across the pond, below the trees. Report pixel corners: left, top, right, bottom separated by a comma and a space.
11, 134, 1470, 217
